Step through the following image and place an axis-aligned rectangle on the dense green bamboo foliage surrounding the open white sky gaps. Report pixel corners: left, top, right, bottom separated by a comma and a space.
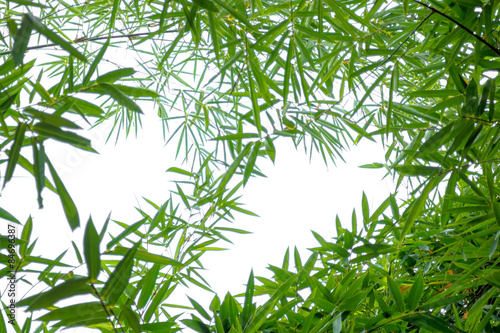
0, 0, 500, 333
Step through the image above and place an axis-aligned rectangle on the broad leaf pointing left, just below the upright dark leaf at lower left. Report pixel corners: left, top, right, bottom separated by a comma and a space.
16, 276, 92, 311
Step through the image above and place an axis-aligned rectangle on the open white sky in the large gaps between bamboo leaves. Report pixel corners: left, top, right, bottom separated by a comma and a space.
0, 107, 392, 332
